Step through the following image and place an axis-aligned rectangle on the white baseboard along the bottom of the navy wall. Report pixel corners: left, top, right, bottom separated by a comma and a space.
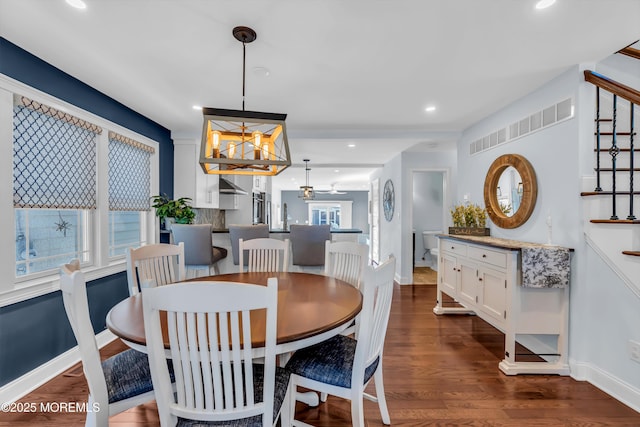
0, 330, 117, 403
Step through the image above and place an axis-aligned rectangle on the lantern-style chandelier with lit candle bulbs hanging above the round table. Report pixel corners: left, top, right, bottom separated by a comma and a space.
200, 27, 291, 176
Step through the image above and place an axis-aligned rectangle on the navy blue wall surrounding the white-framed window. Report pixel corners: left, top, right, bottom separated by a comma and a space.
0, 37, 173, 386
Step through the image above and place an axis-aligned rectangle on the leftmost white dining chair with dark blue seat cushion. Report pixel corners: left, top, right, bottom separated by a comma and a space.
60, 260, 157, 427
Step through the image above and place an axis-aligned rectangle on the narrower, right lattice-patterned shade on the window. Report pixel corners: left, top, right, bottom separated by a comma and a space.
109, 132, 154, 211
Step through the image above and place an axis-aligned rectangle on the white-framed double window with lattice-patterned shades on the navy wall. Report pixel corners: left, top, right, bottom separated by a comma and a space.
0, 79, 159, 300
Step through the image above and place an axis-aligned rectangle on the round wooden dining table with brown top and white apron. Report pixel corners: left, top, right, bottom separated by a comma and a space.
107, 272, 362, 353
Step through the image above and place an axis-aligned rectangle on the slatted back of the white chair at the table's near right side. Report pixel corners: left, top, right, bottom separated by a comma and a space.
351, 256, 396, 389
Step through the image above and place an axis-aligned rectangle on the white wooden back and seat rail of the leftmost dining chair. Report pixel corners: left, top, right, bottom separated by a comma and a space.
60, 259, 154, 427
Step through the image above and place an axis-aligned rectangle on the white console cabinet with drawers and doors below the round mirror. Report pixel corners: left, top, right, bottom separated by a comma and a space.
433, 235, 569, 375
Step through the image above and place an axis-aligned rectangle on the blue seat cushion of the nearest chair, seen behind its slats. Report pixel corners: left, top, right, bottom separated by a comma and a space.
176, 363, 290, 427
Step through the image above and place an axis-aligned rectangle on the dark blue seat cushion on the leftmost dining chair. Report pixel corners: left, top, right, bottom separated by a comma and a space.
102, 349, 153, 403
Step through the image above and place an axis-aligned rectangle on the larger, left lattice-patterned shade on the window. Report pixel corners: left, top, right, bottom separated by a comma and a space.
13, 95, 102, 209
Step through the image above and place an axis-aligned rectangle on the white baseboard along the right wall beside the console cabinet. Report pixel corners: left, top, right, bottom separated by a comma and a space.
569, 361, 640, 412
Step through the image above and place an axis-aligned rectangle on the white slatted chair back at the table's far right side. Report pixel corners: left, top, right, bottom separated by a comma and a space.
324, 240, 369, 289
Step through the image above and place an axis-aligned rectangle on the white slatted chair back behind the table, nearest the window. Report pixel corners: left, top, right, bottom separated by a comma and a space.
127, 242, 185, 296
